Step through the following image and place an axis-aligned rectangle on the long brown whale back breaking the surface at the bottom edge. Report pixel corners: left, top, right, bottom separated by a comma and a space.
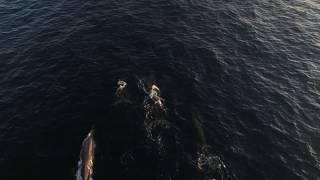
80, 129, 95, 180
